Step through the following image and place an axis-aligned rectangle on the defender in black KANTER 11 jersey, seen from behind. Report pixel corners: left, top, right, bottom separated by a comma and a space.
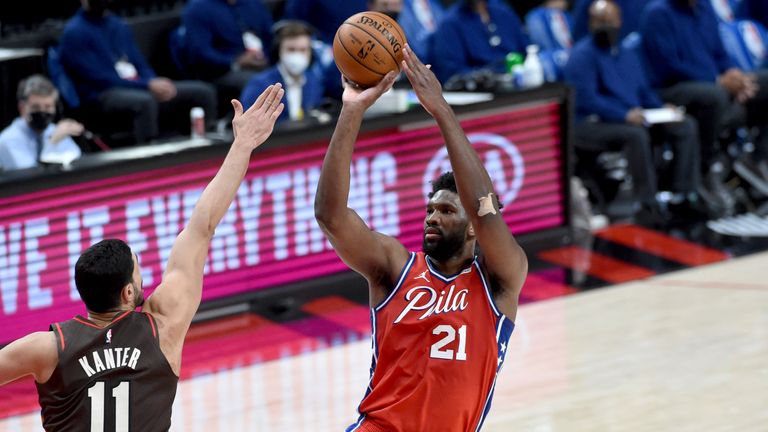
0, 84, 284, 432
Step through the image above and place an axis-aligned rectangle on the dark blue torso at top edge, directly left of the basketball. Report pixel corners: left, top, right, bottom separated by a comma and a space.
285, 0, 368, 44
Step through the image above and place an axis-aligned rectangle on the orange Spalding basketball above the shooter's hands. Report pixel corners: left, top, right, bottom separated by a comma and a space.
333, 11, 406, 87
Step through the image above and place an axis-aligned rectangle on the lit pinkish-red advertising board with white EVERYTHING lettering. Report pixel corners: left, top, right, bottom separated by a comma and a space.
0, 101, 565, 343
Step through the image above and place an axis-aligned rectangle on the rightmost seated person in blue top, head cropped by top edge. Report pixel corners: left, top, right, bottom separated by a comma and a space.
640, 0, 768, 188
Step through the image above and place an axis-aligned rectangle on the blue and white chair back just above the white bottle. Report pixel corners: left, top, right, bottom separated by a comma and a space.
525, 7, 573, 51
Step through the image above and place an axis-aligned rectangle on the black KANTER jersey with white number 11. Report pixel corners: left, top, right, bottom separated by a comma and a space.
37, 311, 179, 432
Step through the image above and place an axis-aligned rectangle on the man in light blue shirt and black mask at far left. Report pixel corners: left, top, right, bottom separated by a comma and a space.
0, 75, 84, 171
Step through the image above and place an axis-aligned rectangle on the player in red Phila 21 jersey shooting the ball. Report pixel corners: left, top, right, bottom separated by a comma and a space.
315, 47, 528, 432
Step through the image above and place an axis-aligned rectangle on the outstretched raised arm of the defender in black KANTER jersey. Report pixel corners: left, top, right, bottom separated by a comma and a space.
144, 84, 284, 373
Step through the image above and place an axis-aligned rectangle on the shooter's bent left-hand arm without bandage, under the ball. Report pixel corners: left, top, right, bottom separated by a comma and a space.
315, 72, 408, 305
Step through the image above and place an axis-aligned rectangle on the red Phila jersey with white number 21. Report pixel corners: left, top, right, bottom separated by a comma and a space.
347, 252, 514, 432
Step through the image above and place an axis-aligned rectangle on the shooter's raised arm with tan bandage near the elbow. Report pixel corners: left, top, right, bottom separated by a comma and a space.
403, 45, 528, 320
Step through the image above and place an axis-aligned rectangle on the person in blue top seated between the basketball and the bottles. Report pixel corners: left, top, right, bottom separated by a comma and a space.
432, 0, 528, 83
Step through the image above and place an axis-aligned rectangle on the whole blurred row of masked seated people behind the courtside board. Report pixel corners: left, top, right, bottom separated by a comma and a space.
0, 0, 768, 228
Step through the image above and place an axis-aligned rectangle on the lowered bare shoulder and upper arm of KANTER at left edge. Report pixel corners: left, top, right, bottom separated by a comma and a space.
0, 332, 59, 385
